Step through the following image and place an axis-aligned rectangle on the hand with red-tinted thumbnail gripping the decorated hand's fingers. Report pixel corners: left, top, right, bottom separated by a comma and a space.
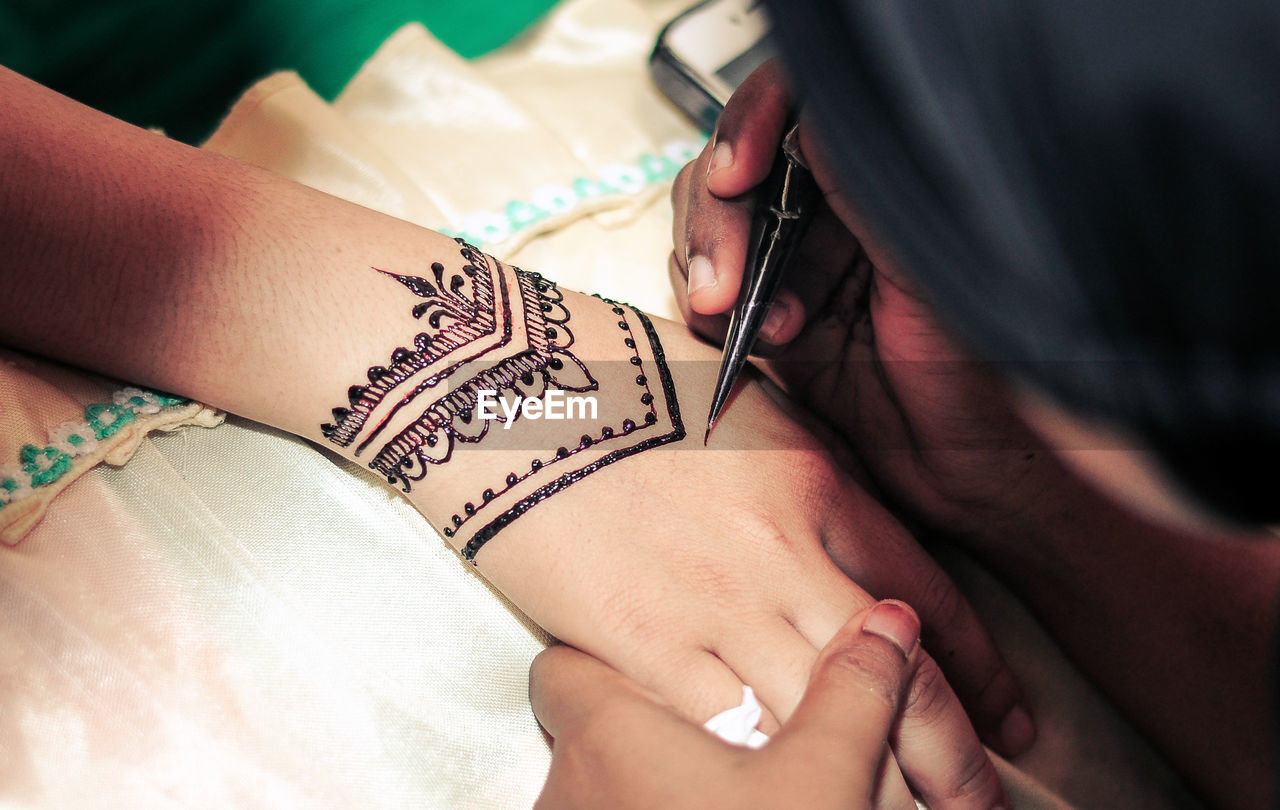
530, 603, 1007, 810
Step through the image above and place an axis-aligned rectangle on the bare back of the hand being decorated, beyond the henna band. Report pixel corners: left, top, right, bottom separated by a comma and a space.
471, 303, 1012, 747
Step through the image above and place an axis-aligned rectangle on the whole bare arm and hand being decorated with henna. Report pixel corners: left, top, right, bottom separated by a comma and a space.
0, 70, 1011, 810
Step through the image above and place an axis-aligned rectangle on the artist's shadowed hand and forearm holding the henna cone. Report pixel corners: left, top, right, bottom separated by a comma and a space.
671, 60, 1280, 807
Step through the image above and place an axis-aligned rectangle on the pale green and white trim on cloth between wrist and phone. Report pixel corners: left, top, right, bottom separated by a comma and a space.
439, 139, 707, 247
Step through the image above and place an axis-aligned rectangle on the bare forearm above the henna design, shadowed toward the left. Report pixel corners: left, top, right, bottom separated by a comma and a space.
0, 63, 458, 433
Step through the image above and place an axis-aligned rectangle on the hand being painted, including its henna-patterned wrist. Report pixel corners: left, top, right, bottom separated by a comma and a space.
296, 238, 1011, 798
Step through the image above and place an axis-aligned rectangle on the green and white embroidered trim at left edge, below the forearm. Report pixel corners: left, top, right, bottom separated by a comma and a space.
0, 388, 191, 509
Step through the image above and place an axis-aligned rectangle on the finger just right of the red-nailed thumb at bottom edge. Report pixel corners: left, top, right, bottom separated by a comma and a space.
893, 653, 1009, 810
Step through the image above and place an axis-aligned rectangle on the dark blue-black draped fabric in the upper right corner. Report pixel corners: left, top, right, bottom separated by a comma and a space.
772, 0, 1280, 523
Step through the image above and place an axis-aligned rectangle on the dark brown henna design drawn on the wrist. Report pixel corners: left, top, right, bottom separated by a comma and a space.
320, 239, 685, 560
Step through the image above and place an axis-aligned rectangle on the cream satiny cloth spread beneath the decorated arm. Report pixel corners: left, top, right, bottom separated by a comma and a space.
0, 0, 1187, 809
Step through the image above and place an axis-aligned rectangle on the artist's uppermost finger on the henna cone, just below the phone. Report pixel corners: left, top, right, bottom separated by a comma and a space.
707, 59, 791, 200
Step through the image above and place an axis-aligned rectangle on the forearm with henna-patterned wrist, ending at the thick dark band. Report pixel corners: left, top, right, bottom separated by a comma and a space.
0, 63, 701, 557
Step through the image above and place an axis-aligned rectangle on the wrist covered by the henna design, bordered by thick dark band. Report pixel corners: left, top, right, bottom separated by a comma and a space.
316, 242, 685, 559
